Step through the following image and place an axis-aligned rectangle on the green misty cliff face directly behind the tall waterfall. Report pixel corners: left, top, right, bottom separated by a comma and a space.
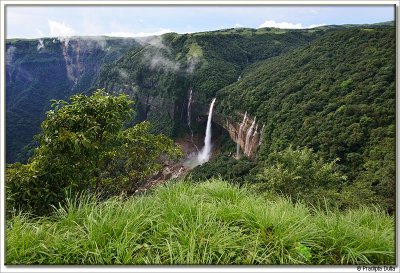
97, 28, 323, 136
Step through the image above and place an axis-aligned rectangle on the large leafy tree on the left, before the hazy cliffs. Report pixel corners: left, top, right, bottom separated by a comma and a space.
6, 90, 181, 214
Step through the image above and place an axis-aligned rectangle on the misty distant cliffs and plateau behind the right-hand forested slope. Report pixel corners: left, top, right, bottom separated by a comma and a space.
6, 22, 391, 163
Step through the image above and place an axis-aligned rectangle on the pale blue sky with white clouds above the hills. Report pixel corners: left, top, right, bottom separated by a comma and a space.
5, 5, 394, 38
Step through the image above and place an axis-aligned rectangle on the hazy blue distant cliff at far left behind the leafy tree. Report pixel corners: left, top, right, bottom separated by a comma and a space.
5, 37, 140, 163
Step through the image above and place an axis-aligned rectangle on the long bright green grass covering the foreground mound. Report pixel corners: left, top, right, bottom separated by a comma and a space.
6, 180, 395, 264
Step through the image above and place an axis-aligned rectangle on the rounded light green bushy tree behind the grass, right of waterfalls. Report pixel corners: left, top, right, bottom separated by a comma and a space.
256, 146, 347, 204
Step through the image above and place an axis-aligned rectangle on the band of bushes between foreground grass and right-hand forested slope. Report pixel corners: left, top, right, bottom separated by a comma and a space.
189, 146, 378, 209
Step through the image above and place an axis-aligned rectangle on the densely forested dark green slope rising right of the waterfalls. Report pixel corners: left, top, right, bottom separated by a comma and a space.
216, 27, 396, 211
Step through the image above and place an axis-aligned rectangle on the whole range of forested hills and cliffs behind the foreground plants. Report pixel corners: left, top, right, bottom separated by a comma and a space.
6, 22, 396, 212
